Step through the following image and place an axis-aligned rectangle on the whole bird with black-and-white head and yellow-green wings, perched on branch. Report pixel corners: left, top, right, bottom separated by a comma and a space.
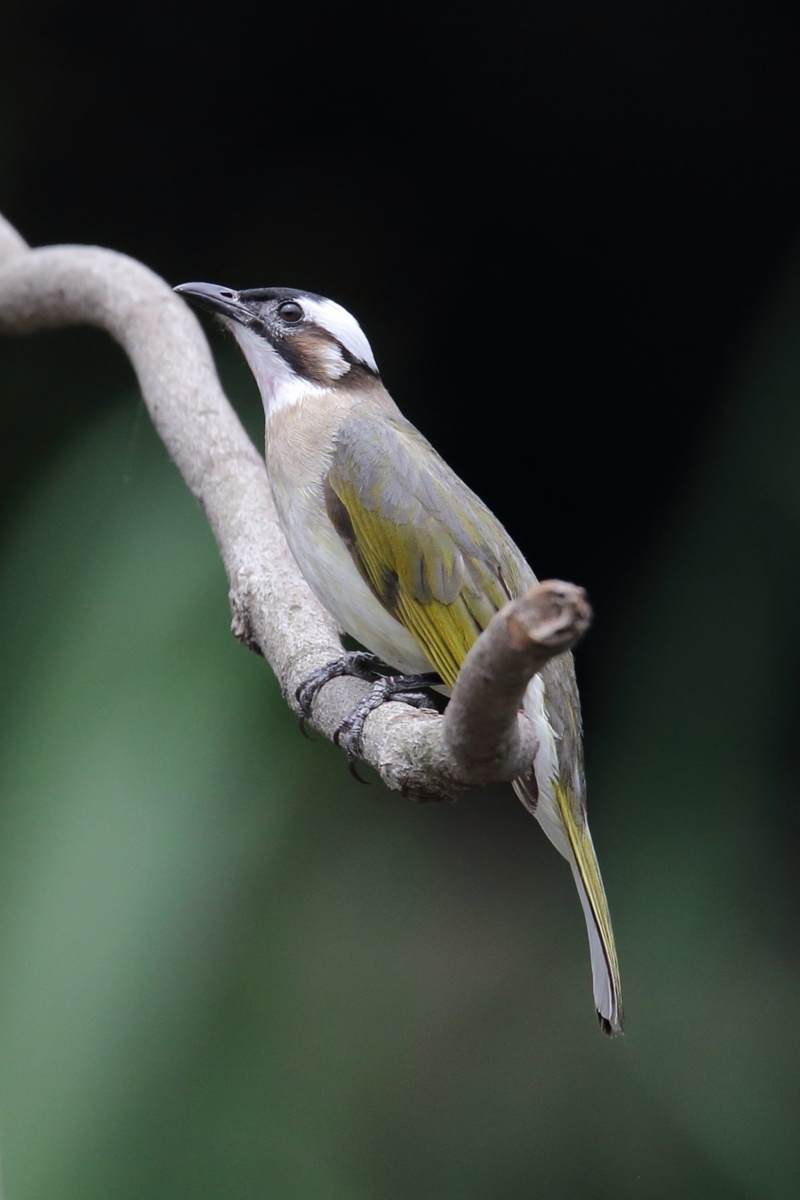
175, 283, 622, 1034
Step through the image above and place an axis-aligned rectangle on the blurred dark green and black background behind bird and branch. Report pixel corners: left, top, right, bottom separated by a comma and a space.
0, 0, 800, 1200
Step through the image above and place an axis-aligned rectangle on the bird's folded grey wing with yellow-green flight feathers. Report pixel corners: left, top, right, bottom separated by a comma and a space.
325, 409, 534, 685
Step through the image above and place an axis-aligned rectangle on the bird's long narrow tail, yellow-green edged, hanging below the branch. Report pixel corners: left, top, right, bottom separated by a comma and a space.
513, 779, 622, 1034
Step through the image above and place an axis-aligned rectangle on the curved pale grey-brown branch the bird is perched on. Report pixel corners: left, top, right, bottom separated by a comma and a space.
0, 217, 589, 798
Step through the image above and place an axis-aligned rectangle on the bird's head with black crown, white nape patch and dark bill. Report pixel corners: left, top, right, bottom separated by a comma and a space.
175, 283, 378, 413
